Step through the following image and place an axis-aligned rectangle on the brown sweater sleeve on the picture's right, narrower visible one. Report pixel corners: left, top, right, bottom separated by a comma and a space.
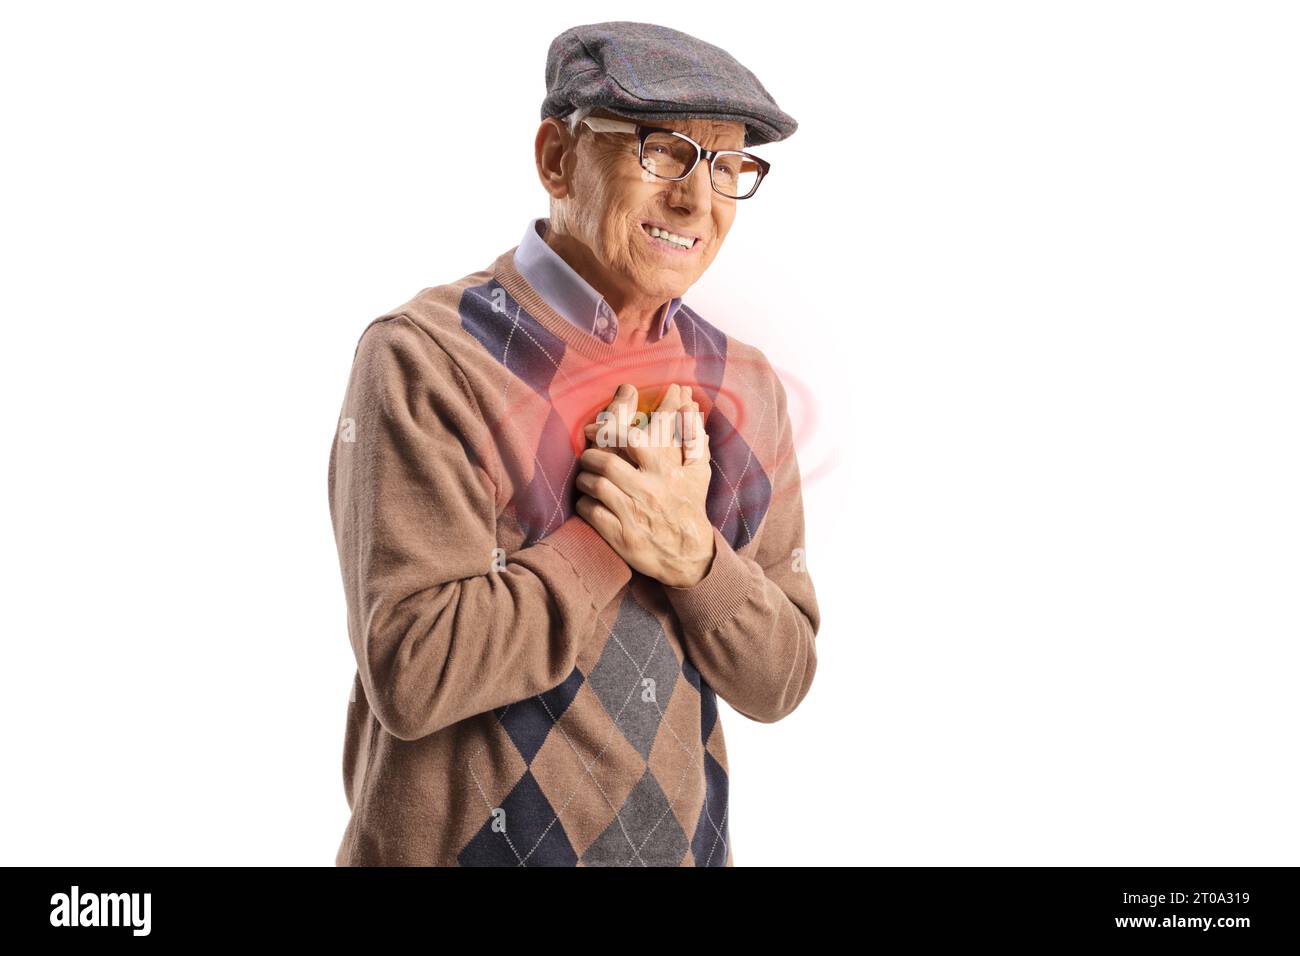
664, 363, 820, 723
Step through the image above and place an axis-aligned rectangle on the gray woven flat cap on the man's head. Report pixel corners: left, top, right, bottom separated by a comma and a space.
541, 21, 798, 146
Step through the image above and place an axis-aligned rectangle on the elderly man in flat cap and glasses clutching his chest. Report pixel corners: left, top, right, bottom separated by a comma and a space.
329, 22, 819, 866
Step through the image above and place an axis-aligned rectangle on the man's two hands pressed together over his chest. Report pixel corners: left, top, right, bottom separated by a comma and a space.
576, 384, 714, 588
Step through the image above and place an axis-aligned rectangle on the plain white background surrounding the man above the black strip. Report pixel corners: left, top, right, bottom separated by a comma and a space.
0, 0, 1300, 866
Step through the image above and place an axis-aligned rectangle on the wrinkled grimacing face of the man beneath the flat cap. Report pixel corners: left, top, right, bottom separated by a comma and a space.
553, 111, 745, 302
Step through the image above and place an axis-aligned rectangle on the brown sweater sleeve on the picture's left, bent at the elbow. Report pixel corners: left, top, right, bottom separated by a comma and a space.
329, 315, 632, 740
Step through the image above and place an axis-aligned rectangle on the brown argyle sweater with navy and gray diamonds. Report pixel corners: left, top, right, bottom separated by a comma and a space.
329, 240, 819, 866
